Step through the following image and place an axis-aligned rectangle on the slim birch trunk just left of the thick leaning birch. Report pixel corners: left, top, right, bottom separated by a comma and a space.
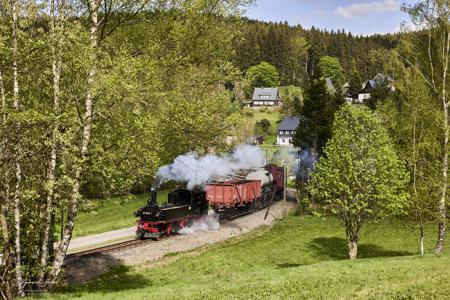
39, 0, 64, 285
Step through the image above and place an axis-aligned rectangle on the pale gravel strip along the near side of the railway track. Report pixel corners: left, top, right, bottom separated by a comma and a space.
65, 195, 296, 283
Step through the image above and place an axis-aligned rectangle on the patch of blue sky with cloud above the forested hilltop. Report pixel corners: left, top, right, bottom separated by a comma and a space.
246, 0, 416, 35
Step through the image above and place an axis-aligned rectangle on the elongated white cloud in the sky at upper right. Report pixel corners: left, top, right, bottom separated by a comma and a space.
334, 0, 400, 18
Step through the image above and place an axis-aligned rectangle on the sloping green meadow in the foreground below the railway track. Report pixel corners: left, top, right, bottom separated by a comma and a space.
43, 215, 450, 299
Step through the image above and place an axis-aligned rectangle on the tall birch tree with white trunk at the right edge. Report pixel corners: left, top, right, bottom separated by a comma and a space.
399, 0, 450, 253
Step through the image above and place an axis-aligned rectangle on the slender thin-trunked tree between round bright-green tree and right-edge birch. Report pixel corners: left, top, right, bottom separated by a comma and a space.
377, 68, 442, 255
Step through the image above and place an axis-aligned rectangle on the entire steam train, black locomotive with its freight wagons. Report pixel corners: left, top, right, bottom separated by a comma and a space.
135, 164, 285, 239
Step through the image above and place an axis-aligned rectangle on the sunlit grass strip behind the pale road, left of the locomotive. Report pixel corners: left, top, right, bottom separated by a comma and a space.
73, 191, 168, 237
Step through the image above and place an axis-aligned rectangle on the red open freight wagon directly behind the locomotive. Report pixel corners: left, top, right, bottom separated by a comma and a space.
206, 180, 261, 207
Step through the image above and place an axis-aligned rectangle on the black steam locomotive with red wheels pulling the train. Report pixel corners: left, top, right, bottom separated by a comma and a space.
134, 189, 208, 239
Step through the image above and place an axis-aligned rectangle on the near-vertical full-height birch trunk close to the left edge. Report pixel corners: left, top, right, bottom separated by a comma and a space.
11, 1, 25, 296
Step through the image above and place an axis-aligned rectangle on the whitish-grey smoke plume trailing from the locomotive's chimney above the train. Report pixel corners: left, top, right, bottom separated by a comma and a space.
153, 145, 264, 190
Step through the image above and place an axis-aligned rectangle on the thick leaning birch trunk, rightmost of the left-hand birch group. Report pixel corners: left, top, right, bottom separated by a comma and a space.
49, 0, 99, 281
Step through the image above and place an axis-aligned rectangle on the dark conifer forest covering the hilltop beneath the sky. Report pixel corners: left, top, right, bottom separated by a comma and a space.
234, 20, 400, 85
